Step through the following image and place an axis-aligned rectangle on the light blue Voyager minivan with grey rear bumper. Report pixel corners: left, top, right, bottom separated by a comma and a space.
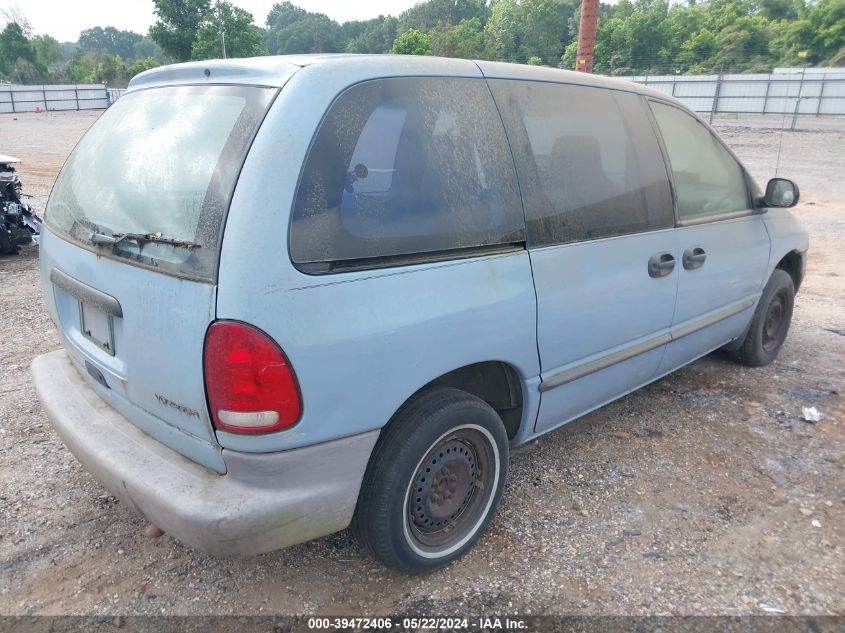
32, 55, 808, 572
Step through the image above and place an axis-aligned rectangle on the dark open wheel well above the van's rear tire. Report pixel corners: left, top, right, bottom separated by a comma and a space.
414, 361, 523, 439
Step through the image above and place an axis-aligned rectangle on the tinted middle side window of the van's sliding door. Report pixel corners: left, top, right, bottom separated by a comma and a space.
490, 80, 674, 246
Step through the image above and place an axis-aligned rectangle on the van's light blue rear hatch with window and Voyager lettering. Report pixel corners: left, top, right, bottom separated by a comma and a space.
41, 85, 277, 472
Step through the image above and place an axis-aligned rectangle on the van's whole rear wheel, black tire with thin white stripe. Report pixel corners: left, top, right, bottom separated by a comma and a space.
352, 387, 508, 573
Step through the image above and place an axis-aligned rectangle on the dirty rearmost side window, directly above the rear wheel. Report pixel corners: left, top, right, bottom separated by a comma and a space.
290, 78, 524, 272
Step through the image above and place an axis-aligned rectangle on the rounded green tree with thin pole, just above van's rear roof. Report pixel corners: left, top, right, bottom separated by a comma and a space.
191, 0, 267, 59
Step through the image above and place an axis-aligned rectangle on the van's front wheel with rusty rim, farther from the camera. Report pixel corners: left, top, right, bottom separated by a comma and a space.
733, 268, 795, 367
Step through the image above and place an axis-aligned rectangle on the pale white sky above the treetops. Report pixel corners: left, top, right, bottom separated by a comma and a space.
0, 0, 419, 42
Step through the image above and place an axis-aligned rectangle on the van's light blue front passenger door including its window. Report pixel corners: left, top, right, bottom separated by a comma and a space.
650, 101, 769, 374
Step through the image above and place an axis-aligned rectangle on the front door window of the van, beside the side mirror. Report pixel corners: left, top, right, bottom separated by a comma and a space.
651, 101, 748, 221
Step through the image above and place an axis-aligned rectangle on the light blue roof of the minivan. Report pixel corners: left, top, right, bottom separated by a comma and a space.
129, 53, 671, 99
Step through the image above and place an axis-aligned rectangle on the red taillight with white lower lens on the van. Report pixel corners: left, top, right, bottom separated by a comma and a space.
203, 321, 302, 433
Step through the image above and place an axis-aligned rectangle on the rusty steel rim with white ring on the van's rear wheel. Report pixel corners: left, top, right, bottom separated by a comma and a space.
403, 425, 501, 558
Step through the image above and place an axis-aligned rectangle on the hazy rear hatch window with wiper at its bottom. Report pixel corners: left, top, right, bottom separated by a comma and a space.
46, 86, 275, 281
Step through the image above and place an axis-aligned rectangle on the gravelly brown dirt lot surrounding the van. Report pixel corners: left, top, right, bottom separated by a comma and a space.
0, 113, 845, 615
